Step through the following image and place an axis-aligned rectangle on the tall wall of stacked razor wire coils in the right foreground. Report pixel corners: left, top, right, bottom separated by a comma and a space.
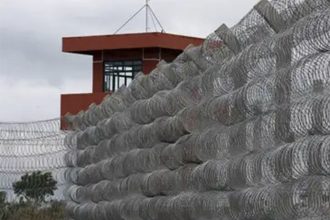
65, 0, 330, 220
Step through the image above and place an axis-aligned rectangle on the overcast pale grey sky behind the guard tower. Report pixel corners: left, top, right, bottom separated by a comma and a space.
0, 0, 257, 121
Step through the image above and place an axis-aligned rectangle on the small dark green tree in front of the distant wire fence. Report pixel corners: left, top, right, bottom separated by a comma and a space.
13, 171, 57, 204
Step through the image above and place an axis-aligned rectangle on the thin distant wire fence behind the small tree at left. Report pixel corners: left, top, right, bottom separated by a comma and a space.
0, 119, 68, 200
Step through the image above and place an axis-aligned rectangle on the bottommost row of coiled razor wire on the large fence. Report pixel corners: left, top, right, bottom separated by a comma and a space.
67, 176, 330, 220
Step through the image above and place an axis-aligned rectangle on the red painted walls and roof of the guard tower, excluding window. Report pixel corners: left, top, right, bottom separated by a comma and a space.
61, 33, 204, 128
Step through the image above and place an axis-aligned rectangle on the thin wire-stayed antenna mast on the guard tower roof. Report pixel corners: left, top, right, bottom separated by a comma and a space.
113, 0, 165, 34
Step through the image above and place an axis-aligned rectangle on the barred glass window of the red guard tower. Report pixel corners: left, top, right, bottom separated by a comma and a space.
104, 60, 142, 92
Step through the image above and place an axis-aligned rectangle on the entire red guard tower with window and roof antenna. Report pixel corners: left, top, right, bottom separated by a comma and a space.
61, 1, 204, 128
